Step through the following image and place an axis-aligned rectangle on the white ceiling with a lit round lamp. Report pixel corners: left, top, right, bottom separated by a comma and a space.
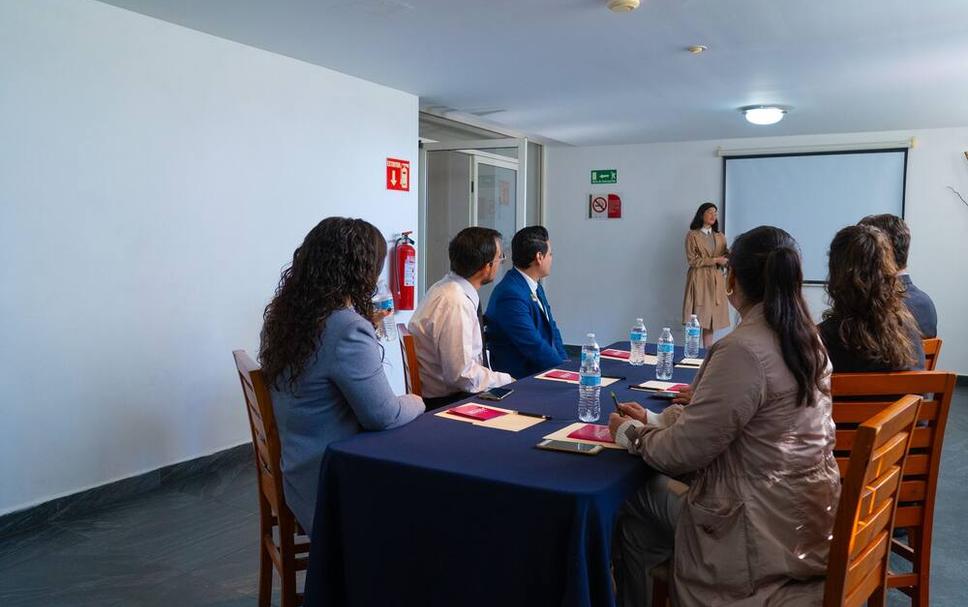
96, 0, 968, 145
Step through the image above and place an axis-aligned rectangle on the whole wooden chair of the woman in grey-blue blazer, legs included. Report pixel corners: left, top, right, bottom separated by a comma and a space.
232, 350, 309, 607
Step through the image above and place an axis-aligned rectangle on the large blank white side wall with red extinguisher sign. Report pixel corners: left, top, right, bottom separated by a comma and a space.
0, 0, 417, 513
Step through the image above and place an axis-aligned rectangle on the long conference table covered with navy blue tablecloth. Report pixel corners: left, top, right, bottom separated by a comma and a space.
305, 342, 696, 607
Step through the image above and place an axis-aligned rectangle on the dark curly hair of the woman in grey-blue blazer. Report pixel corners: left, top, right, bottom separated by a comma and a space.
259, 217, 387, 392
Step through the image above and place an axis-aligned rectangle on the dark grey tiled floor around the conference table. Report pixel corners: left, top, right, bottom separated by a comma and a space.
0, 388, 968, 607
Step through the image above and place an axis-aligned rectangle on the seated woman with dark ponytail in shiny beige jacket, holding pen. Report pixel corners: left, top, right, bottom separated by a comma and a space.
609, 226, 840, 607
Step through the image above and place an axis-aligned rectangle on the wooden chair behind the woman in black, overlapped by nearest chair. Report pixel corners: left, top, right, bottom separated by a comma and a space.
831, 371, 957, 607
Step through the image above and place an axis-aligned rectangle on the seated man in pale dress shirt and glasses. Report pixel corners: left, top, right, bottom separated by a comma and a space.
408, 227, 514, 410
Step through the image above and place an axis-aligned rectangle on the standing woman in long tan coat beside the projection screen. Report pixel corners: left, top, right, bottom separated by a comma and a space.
682, 202, 729, 348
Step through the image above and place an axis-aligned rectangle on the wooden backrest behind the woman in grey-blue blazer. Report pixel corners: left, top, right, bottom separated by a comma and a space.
232, 350, 296, 535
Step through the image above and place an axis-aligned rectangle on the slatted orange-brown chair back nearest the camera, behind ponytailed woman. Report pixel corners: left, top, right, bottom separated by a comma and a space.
824, 395, 921, 607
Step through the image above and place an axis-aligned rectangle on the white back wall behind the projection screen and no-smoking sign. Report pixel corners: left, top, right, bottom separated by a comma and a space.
547, 128, 968, 374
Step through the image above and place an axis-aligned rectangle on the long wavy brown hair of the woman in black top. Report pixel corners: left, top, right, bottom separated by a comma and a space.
824, 225, 917, 369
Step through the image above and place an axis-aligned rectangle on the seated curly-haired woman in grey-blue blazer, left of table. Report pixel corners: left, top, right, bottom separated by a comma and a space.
259, 217, 424, 532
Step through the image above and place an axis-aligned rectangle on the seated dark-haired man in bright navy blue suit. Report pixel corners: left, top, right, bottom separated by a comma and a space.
485, 226, 568, 378
